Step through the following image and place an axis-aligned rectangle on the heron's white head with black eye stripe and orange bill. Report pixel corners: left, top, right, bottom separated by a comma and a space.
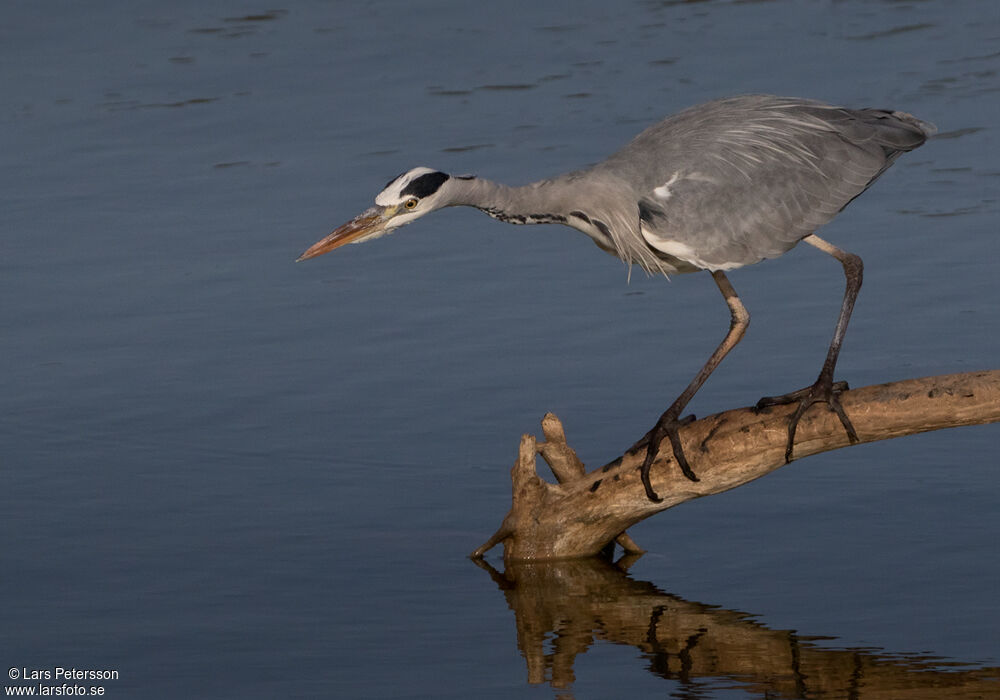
299, 167, 451, 260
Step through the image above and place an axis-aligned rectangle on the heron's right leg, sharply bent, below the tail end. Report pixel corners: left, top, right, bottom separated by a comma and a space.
757, 234, 864, 464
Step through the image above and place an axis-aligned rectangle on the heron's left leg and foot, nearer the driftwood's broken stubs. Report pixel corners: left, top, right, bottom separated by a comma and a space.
629, 271, 750, 503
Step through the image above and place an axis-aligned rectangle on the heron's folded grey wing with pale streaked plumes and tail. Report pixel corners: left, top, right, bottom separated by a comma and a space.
592, 96, 933, 270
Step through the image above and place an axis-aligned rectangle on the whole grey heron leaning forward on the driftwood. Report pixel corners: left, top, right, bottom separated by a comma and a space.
299, 95, 935, 502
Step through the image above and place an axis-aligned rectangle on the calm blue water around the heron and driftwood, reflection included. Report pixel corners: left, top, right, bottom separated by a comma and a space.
0, 0, 1000, 698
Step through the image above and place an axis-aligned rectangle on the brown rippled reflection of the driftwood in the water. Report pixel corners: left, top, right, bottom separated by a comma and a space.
476, 558, 1000, 700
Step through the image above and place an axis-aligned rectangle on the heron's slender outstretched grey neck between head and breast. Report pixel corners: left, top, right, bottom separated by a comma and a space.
449, 177, 571, 224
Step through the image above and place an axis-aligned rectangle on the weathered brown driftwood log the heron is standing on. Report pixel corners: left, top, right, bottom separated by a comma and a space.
471, 370, 1000, 560
